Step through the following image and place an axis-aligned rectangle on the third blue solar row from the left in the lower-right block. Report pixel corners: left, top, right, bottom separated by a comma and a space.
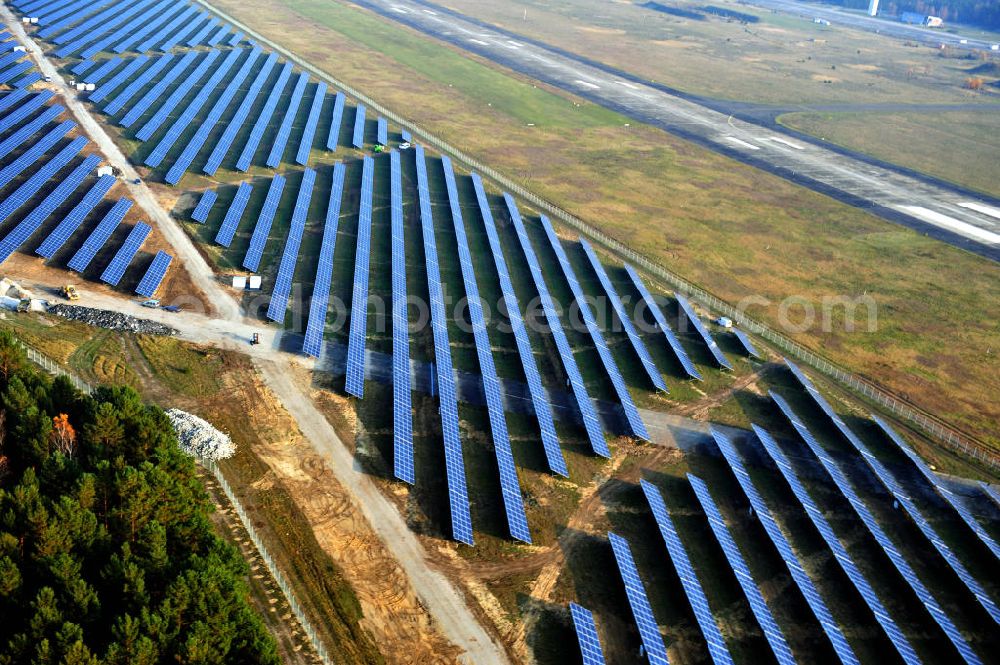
639, 480, 733, 665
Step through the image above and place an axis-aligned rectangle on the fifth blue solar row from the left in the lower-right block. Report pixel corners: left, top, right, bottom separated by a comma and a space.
712, 427, 859, 664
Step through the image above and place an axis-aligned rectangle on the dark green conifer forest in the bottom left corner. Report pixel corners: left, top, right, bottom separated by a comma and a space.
0, 332, 278, 665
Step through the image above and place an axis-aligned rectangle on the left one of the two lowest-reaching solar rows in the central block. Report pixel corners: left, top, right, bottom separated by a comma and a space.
415, 146, 472, 545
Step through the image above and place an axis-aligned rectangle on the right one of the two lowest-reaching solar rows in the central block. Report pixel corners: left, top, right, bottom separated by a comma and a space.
441, 156, 531, 543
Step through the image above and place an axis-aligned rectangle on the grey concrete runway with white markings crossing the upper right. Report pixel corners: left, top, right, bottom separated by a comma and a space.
355, 0, 1000, 261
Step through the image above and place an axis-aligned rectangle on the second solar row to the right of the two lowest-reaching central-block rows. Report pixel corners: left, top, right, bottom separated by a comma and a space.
504, 195, 611, 457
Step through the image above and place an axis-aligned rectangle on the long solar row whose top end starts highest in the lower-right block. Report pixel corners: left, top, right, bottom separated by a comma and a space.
786, 361, 1000, 623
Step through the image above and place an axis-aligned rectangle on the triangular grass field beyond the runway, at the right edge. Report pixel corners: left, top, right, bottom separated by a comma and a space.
778, 111, 1000, 196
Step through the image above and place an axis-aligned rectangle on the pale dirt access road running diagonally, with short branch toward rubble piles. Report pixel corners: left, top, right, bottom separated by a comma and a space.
0, 13, 509, 665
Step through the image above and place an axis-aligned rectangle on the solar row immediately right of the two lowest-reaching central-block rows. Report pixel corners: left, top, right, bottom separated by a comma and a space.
472, 173, 569, 477
